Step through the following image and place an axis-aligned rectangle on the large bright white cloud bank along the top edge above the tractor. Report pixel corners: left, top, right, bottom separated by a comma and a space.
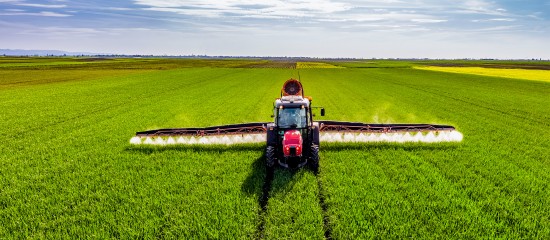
134, 0, 507, 24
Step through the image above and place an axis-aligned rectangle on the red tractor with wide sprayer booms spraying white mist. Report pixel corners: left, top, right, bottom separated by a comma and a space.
130, 79, 462, 171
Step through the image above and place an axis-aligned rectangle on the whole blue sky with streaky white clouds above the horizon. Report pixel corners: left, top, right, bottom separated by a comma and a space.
0, 0, 550, 59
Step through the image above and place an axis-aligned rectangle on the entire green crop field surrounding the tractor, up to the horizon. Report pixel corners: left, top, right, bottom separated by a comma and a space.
0, 57, 550, 239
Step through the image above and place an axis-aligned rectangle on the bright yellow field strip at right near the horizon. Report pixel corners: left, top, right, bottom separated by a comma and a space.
414, 66, 550, 82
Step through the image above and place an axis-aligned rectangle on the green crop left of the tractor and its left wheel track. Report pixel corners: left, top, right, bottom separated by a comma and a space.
0, 64, 286, 238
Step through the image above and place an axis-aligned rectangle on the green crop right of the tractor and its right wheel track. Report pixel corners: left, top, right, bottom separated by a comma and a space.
301, 69, 550, 238
